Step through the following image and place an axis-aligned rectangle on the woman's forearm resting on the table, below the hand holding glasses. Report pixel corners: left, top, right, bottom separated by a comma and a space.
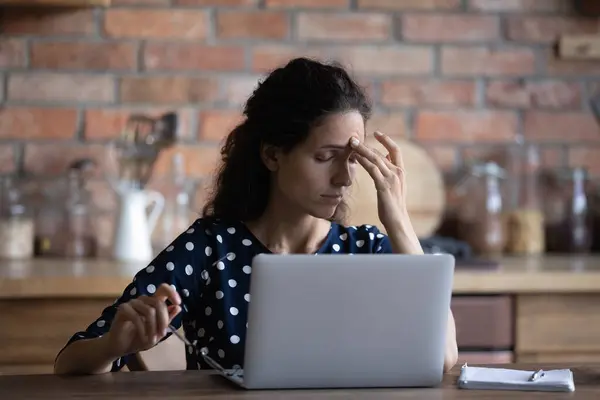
54, 336, 119, 375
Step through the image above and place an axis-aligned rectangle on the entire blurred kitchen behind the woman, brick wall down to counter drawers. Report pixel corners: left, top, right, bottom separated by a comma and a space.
0, 0, 600, 373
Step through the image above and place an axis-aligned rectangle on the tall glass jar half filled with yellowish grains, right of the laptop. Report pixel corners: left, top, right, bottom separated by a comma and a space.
506, 143, 546, 255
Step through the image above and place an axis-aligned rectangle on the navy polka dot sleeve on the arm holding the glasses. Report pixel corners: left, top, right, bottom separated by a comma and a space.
56, 220, 207, 372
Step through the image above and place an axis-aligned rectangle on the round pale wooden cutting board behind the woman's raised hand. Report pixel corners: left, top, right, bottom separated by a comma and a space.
348, 137, 446, 238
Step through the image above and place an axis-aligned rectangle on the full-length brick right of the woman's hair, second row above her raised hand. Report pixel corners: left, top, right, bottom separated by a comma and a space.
381, 78, 475, 106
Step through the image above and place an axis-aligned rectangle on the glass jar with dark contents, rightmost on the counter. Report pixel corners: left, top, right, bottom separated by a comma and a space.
545, 167, 593, 253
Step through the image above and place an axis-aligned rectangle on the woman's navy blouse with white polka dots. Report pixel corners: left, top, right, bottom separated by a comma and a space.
56, 218, 392, 371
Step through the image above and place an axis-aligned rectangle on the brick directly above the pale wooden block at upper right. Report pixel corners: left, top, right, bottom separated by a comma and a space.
507, 16, 598, 43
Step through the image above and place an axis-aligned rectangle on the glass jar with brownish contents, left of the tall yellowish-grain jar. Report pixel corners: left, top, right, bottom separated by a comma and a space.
458, 162, 506, 256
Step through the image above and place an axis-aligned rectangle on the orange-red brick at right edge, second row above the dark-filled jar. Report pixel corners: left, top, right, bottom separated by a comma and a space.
524, 111, 600, 142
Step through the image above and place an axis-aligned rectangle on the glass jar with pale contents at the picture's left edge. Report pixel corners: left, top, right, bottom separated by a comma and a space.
0, 176, 34, 260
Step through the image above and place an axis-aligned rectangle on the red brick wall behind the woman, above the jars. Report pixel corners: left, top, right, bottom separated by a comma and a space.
0, 0, 600, 245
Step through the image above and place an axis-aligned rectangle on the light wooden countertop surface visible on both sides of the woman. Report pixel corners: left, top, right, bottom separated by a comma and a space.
0, 255, 600, 299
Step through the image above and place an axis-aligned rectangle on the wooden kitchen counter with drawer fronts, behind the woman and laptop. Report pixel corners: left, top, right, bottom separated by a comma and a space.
0, 255, 600, 375
